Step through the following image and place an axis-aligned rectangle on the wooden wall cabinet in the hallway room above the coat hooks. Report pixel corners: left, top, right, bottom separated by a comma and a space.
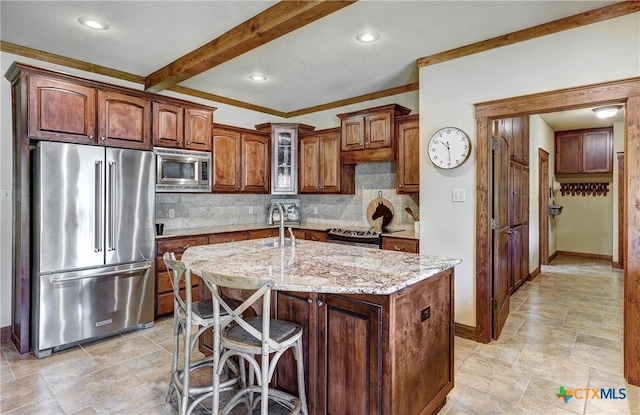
555, 127, 613, 174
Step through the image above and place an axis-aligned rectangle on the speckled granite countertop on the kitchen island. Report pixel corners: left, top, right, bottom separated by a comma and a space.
182, 240, 462, 295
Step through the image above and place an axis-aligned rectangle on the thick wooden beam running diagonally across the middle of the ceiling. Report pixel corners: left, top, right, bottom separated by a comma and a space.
145, 0, 355, 92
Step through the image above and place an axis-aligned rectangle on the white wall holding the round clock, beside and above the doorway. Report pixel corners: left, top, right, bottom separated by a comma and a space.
420, 13, 640, 326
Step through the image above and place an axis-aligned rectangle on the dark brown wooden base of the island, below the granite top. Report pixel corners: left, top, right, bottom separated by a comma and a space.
201, 268, 454, 415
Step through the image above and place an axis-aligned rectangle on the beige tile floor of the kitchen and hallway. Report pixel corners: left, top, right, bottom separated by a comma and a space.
0, 257, 640, 415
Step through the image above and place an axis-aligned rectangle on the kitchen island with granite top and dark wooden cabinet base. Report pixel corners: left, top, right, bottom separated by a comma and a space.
182, 239, 460, 414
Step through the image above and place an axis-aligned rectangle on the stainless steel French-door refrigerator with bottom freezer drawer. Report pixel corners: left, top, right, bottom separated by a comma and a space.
31, 141, 155, 357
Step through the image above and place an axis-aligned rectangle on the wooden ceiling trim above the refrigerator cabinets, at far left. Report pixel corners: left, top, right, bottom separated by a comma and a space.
0, 40, 144, 84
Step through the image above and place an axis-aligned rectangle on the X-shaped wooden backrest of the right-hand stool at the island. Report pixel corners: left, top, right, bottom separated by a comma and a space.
202, 271, 284, 351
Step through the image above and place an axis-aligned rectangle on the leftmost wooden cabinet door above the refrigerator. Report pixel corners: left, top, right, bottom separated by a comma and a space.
28, 75, 96, 143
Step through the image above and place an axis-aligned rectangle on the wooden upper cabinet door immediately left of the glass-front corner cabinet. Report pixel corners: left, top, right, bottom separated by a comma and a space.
240, 133, 271, 193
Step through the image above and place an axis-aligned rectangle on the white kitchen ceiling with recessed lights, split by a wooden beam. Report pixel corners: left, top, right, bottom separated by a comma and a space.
0, 0, 616, 128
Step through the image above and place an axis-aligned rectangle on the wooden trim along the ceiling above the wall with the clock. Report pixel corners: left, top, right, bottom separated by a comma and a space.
418, 0, 640, 68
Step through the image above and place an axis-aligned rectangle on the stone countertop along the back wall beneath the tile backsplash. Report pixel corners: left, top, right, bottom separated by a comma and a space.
156, 222, 420, 240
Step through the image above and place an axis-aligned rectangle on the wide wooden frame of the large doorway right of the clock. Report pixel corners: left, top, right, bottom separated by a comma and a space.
475, 77, 640, 385
